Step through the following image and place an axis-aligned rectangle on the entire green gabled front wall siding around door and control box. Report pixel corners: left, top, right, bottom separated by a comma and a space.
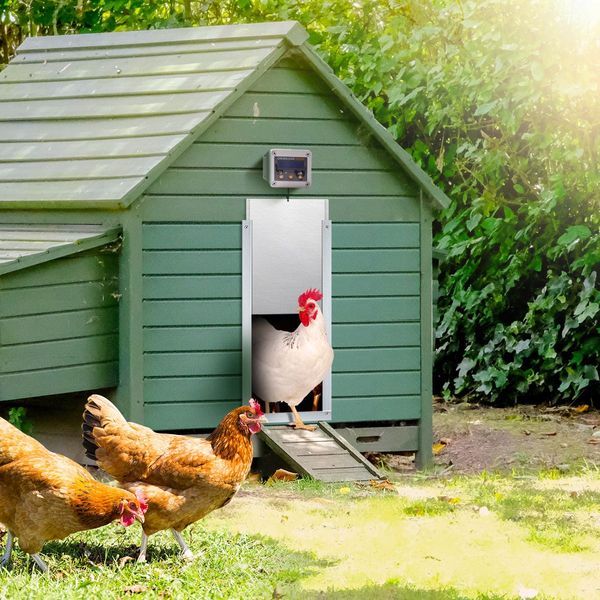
140, 63, 420, 429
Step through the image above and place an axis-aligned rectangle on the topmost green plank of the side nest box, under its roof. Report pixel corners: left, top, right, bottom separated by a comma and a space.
0, 253, 117, 290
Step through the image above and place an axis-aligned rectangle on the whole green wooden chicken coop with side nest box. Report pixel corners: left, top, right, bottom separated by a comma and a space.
0, 22, 448, 474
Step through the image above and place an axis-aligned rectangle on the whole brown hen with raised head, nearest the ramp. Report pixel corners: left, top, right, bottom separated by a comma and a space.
83, 394, 263, 561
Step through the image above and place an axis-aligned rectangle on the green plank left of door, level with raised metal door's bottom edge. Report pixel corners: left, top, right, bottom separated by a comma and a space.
143, 300, 242, 327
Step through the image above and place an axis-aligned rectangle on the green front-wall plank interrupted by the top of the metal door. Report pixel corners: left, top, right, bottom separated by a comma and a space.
141, 196, 420, 223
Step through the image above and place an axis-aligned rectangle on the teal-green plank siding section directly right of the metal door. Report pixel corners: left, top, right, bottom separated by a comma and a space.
332, 222, 421, 422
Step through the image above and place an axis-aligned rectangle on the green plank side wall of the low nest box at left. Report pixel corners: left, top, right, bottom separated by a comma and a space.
0, 250, 119, 400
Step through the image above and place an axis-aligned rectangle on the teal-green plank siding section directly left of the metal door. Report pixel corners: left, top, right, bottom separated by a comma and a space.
142, 222, 242, 429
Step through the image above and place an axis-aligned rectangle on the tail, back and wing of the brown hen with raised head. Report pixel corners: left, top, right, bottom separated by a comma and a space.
83, 394, 214, 489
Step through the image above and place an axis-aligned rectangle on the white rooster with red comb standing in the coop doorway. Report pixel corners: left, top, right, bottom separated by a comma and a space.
252, 289, 333, 430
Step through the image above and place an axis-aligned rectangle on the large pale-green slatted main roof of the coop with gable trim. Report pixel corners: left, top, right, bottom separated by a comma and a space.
0, 21, 448, 209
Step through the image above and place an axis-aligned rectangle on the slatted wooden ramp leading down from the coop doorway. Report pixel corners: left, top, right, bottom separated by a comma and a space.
260, 422, 382, 482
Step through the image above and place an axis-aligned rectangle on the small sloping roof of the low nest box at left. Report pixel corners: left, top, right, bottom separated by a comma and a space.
0, 224, 121, 275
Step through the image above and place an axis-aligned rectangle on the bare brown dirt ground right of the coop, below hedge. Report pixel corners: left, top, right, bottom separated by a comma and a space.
374, 402, 600, 474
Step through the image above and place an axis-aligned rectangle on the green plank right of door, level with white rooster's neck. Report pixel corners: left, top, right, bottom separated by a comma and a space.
332, 322, 421, 348
